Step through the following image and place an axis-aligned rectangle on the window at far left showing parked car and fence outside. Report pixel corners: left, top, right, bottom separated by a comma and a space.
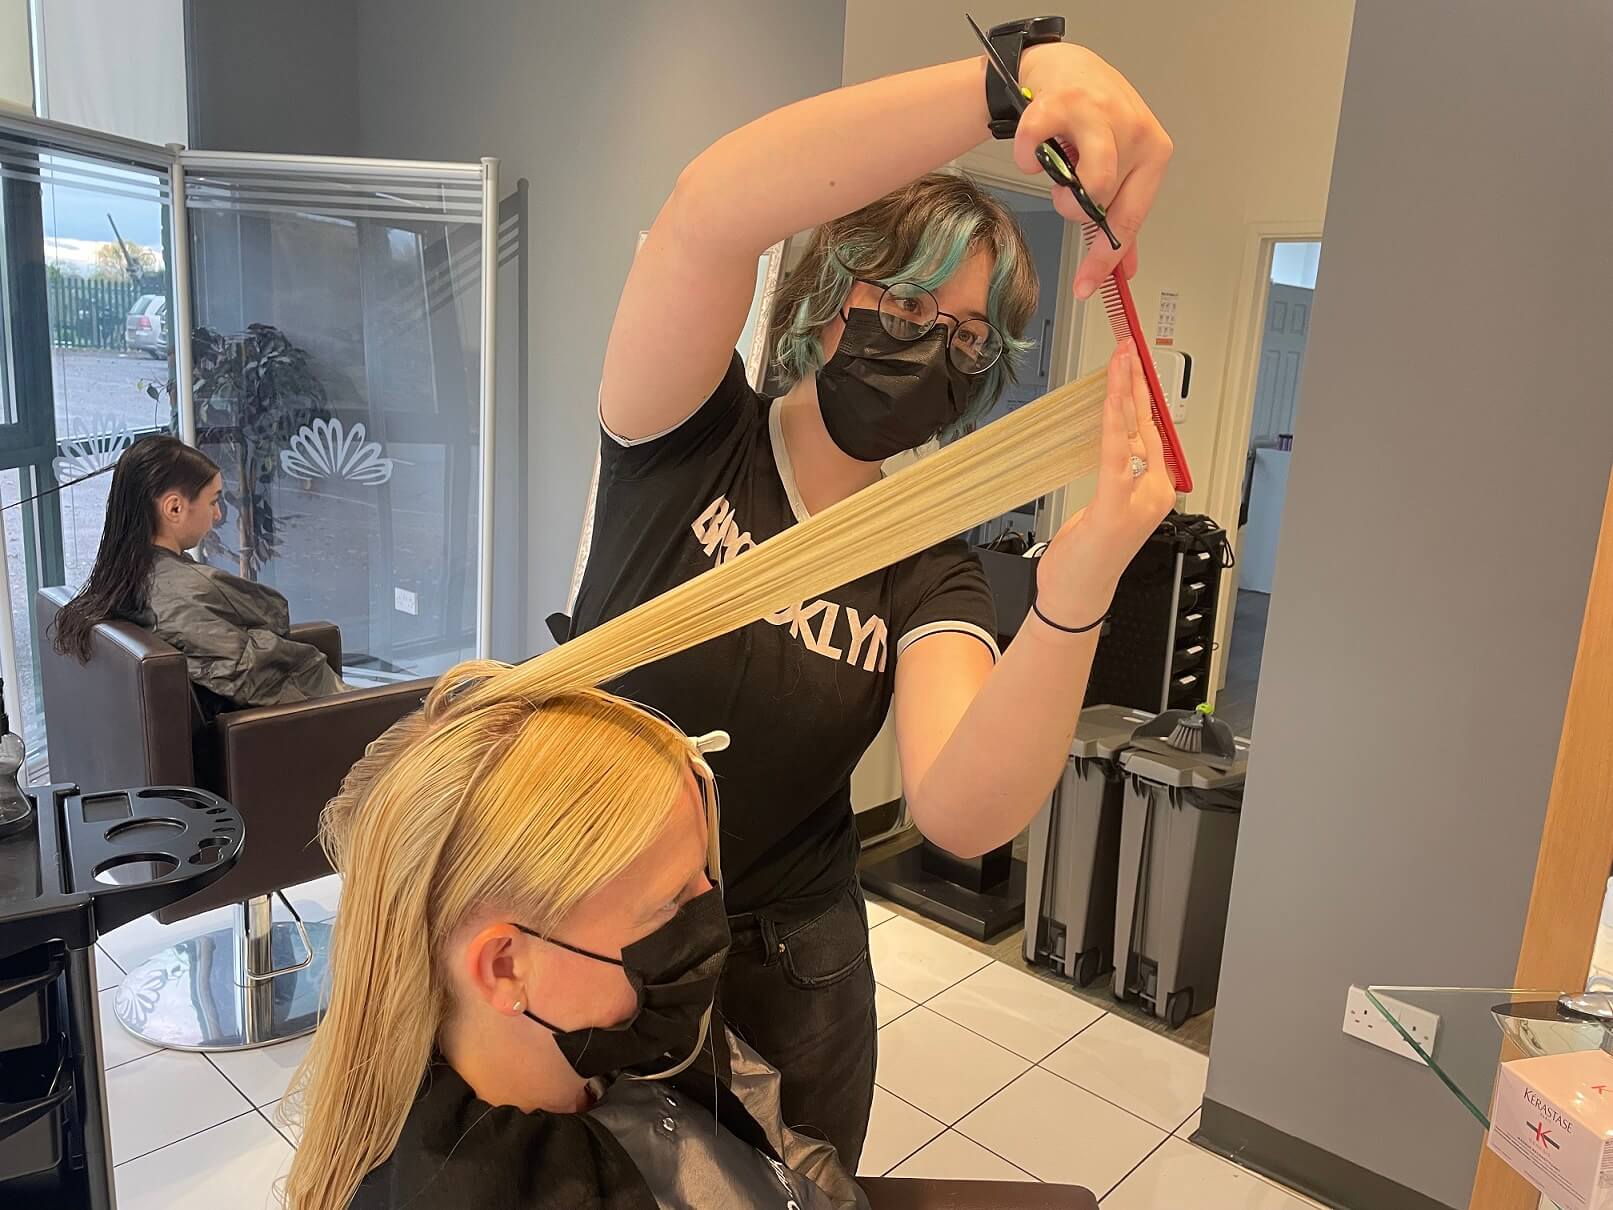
0, 119, 173, 749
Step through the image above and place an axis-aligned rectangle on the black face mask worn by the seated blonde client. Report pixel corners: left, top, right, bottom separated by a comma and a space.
516, 887, 729, 1079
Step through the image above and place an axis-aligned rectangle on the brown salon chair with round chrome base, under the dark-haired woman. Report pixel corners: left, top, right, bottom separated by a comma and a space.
34, 587, 431, 1050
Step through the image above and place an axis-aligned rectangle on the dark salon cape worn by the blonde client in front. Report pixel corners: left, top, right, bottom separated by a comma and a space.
350, 1034, 866, 1210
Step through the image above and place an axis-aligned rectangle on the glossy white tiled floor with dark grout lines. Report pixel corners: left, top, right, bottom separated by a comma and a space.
97, 878, 1313, 1210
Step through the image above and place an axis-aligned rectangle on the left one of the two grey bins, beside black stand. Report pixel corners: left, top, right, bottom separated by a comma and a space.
1024, 705, 1153, 987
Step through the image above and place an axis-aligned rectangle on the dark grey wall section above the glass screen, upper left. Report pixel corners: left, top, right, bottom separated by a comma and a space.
185, 0, 358, 155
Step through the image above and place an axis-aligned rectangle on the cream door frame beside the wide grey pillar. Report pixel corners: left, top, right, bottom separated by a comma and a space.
1203, 218, 1323, 695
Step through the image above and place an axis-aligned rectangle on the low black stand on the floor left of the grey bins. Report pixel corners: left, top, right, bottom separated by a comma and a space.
861, 841, 1024, 941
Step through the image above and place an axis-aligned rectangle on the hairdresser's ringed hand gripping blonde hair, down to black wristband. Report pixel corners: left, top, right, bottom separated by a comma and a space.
1037, 340, 1176, 626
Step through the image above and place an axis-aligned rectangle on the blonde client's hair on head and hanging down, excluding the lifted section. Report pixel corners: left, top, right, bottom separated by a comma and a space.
282, 677, 697, 1210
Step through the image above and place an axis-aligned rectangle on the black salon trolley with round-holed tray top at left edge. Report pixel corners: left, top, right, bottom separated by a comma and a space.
0, 786, 245, 1210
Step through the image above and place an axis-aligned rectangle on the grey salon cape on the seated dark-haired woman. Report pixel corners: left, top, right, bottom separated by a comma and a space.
129, 547, 347, 707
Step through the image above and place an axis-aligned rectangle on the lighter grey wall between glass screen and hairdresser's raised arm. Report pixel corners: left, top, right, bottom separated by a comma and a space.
348, 0, 845, 655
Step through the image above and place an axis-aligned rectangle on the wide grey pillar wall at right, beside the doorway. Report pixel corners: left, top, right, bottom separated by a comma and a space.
1208, 0, 1613, 1207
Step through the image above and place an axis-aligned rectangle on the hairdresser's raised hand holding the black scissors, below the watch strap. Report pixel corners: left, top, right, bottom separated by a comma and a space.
1013, 42, 1173, 298
